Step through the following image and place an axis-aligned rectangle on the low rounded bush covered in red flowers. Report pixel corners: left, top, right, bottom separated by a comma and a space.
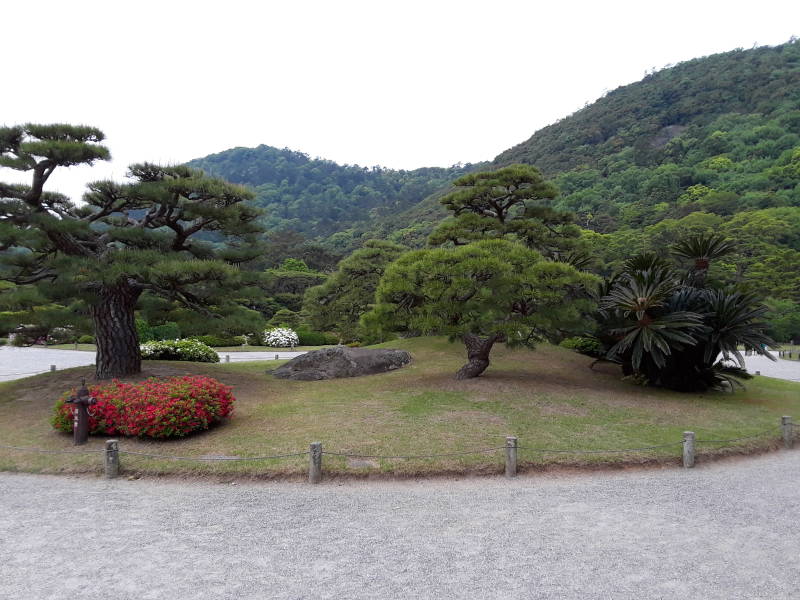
52, 375, 235, 438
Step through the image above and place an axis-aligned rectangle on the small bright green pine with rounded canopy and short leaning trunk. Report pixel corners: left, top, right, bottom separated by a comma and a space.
364, 240, 597, 379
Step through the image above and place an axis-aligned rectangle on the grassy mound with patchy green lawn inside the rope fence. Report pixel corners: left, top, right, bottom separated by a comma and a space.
0, 338, 800, 477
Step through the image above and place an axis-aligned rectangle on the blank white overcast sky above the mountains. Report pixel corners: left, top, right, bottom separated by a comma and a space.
0, 0, 800, 200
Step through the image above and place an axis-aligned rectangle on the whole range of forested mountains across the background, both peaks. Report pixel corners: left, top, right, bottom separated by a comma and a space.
186, 40, 800, 310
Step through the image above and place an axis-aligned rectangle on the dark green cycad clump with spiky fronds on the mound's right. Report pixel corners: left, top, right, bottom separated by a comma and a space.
598, 237, 774, 391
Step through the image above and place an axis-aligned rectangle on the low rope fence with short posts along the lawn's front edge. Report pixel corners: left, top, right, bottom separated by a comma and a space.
0, 416, 800, 483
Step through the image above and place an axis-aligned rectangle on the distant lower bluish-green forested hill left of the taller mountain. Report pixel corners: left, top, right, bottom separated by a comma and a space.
189, 145, 469, 240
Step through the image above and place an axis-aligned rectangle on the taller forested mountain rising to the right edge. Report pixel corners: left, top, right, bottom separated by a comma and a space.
494, 42, 800, 232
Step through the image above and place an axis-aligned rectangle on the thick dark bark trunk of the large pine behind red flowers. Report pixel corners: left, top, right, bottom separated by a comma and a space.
90, 284, 142, 379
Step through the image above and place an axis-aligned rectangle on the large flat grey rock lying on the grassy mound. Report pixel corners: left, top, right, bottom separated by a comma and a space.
272, 346, 411, 381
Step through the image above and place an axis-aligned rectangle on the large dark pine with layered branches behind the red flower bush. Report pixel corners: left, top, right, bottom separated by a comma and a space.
0, 125, 258, 379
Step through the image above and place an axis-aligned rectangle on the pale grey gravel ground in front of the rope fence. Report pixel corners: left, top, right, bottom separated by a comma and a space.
0, 451, 800, 600
